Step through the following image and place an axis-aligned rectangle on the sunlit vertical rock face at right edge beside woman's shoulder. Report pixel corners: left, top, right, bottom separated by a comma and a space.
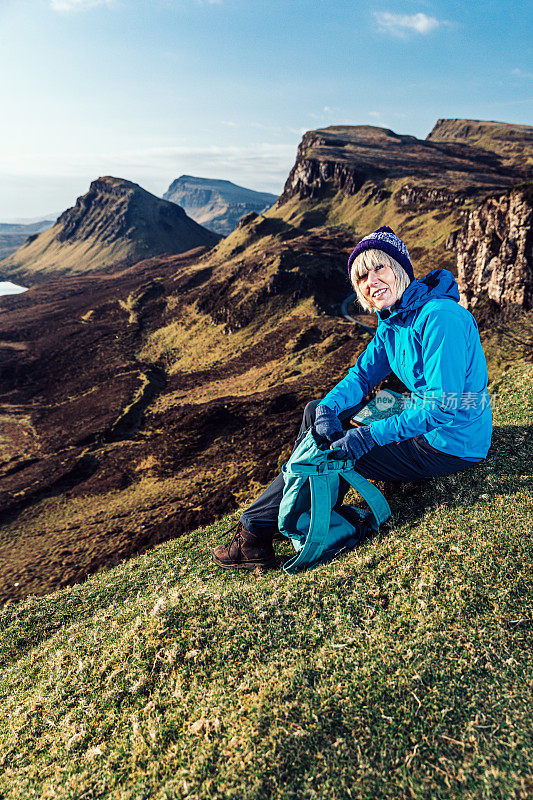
455, 184, 533, 310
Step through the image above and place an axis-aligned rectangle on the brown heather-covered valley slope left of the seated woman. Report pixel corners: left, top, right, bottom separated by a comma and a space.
0, 221, 369, 601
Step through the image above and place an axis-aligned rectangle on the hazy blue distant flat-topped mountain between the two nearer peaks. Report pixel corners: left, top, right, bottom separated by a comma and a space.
163, 175, 276, 236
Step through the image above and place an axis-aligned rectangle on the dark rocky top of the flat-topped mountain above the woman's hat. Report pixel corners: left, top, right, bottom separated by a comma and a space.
278, 125, 529, 205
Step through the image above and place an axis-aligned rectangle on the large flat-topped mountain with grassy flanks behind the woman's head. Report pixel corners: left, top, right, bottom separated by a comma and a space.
267, 120, 533, 277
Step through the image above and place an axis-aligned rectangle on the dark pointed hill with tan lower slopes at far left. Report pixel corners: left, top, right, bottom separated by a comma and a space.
0, 176, 220, 280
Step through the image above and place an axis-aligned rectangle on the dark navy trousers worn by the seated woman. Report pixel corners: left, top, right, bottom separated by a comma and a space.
240, 400, 480, 536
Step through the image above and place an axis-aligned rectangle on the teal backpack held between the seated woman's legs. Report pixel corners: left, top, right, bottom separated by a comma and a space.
278, 428, 390, 575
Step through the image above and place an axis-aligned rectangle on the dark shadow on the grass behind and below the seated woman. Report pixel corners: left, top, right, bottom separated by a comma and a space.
381, 425, 533, 536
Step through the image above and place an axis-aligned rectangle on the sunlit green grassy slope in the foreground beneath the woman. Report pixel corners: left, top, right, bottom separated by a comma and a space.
0, 363, 533, 800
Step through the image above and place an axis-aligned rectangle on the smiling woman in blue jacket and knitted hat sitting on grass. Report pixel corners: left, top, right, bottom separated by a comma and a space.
213, 227, 492, 569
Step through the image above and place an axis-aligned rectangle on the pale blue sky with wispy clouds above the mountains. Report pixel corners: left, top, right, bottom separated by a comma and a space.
0, 0, 533, 220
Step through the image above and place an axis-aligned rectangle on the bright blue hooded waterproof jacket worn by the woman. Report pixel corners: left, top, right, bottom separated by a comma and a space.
321, 269, 492, 461
